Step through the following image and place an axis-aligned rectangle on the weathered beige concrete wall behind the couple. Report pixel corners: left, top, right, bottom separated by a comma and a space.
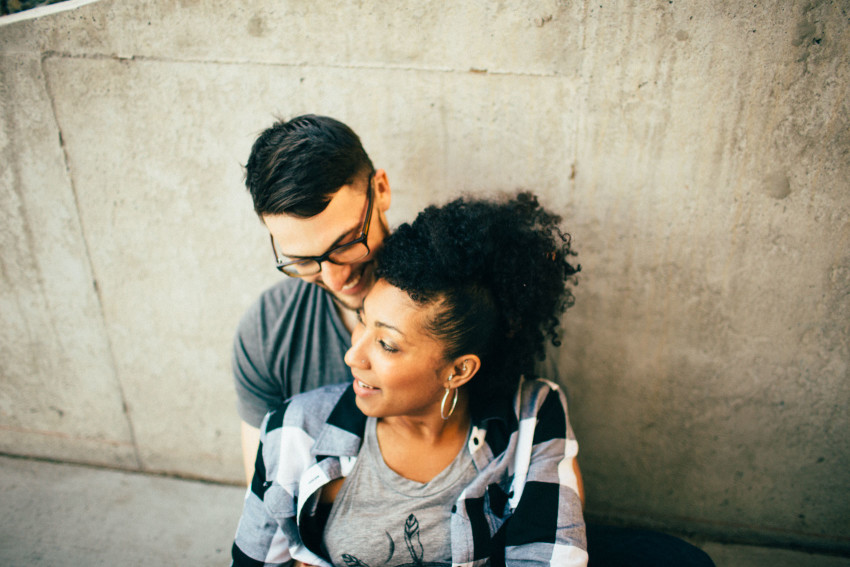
0, 0, 850, 550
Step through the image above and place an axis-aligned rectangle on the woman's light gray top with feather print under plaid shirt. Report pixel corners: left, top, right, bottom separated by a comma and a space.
323, 417, 477, 567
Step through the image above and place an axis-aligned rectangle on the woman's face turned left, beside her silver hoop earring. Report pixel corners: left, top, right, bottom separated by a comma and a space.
345, 280, 452, 417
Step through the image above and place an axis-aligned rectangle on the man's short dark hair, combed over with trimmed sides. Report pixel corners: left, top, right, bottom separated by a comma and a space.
245, 114, 374, 218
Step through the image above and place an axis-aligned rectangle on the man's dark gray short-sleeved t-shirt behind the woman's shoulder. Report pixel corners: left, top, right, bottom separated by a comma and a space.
233, 278, 354, 427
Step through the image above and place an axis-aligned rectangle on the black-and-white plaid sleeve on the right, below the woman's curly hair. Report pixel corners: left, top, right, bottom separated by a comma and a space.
505, 381, 588, 566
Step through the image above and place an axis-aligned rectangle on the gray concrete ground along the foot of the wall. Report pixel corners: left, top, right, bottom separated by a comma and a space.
0, 456, 850, 567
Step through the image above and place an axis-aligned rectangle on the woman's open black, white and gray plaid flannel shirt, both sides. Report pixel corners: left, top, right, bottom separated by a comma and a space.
232, 380, 587, 567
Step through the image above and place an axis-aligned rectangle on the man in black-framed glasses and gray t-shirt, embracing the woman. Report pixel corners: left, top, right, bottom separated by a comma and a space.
233, 115, 390, 483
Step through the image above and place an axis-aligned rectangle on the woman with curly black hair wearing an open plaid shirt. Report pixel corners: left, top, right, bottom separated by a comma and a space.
233, 193, 587, 567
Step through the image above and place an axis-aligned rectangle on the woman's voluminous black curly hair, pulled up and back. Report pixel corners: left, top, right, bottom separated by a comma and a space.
377, 192, 581, 406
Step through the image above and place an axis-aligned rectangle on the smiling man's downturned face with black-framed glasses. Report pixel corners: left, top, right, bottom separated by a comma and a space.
263, 169, 390, 309
